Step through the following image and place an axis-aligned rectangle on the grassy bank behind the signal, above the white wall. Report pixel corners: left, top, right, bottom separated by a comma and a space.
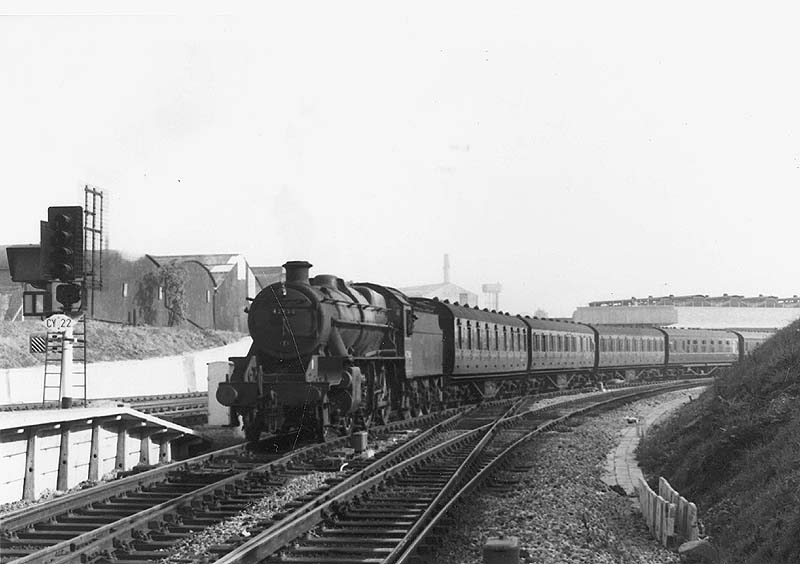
0, 319, 247, 368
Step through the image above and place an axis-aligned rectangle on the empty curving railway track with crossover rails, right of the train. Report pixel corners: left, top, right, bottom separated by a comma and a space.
217, 382, 697, 564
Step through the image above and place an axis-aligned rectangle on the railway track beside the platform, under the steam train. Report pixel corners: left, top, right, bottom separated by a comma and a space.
0, 410, 468, 564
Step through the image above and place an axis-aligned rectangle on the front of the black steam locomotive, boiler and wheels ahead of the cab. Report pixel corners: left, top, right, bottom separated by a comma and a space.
217, 261, 402, 440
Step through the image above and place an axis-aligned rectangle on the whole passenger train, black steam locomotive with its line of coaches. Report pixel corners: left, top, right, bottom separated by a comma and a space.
216, 261, 767, 440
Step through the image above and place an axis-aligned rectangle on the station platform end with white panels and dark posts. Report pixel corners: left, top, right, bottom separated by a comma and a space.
0, 406, 204, 503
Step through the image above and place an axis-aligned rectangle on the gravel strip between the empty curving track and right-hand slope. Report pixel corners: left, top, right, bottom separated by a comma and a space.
434, 392, 682, 564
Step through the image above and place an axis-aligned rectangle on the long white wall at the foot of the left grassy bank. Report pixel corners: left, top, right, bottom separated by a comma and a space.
0, 337, 252, 405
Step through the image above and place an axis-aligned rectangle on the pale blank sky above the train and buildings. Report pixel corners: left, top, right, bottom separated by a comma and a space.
0, 1, 800, 315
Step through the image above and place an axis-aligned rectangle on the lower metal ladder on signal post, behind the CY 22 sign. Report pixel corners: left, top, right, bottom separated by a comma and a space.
42, 315, 86, 405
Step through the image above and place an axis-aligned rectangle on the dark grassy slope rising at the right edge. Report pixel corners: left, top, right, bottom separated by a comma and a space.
639, 321, 800, 564
